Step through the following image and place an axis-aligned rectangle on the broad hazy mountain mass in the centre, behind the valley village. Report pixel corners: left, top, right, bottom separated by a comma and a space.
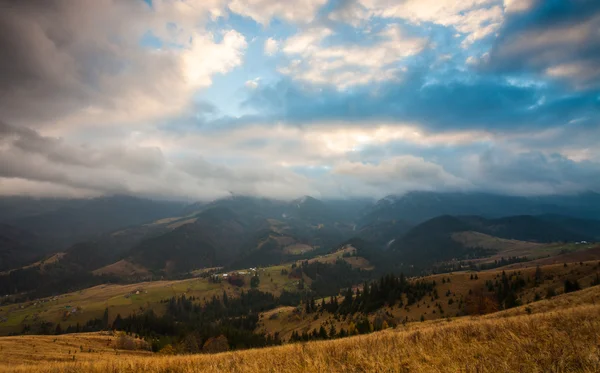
123, 196, 364, 274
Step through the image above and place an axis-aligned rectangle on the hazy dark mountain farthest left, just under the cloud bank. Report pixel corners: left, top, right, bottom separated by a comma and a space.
11, 196, 183, 246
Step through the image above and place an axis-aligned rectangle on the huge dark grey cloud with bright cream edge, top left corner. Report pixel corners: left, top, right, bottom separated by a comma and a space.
0, 0, 246, 127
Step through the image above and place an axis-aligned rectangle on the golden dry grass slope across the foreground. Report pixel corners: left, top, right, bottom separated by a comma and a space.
0, 287, 600, 373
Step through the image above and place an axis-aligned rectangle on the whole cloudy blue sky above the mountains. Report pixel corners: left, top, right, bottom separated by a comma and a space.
0, 0, 600, 200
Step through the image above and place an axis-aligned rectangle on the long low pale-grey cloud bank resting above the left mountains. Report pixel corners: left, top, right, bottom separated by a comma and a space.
0, 120, 318, 200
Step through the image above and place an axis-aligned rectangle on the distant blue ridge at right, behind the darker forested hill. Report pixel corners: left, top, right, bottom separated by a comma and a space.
359, 192, 600, 226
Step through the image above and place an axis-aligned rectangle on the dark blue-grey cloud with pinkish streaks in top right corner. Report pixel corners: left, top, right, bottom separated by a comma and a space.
481, 0, 600, 89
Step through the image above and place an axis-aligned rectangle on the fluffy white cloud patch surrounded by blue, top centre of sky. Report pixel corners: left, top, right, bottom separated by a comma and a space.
279, 25, 427, 89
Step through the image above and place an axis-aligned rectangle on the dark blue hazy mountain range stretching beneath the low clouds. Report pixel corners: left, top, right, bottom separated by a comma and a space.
0, 192, 600, 298
